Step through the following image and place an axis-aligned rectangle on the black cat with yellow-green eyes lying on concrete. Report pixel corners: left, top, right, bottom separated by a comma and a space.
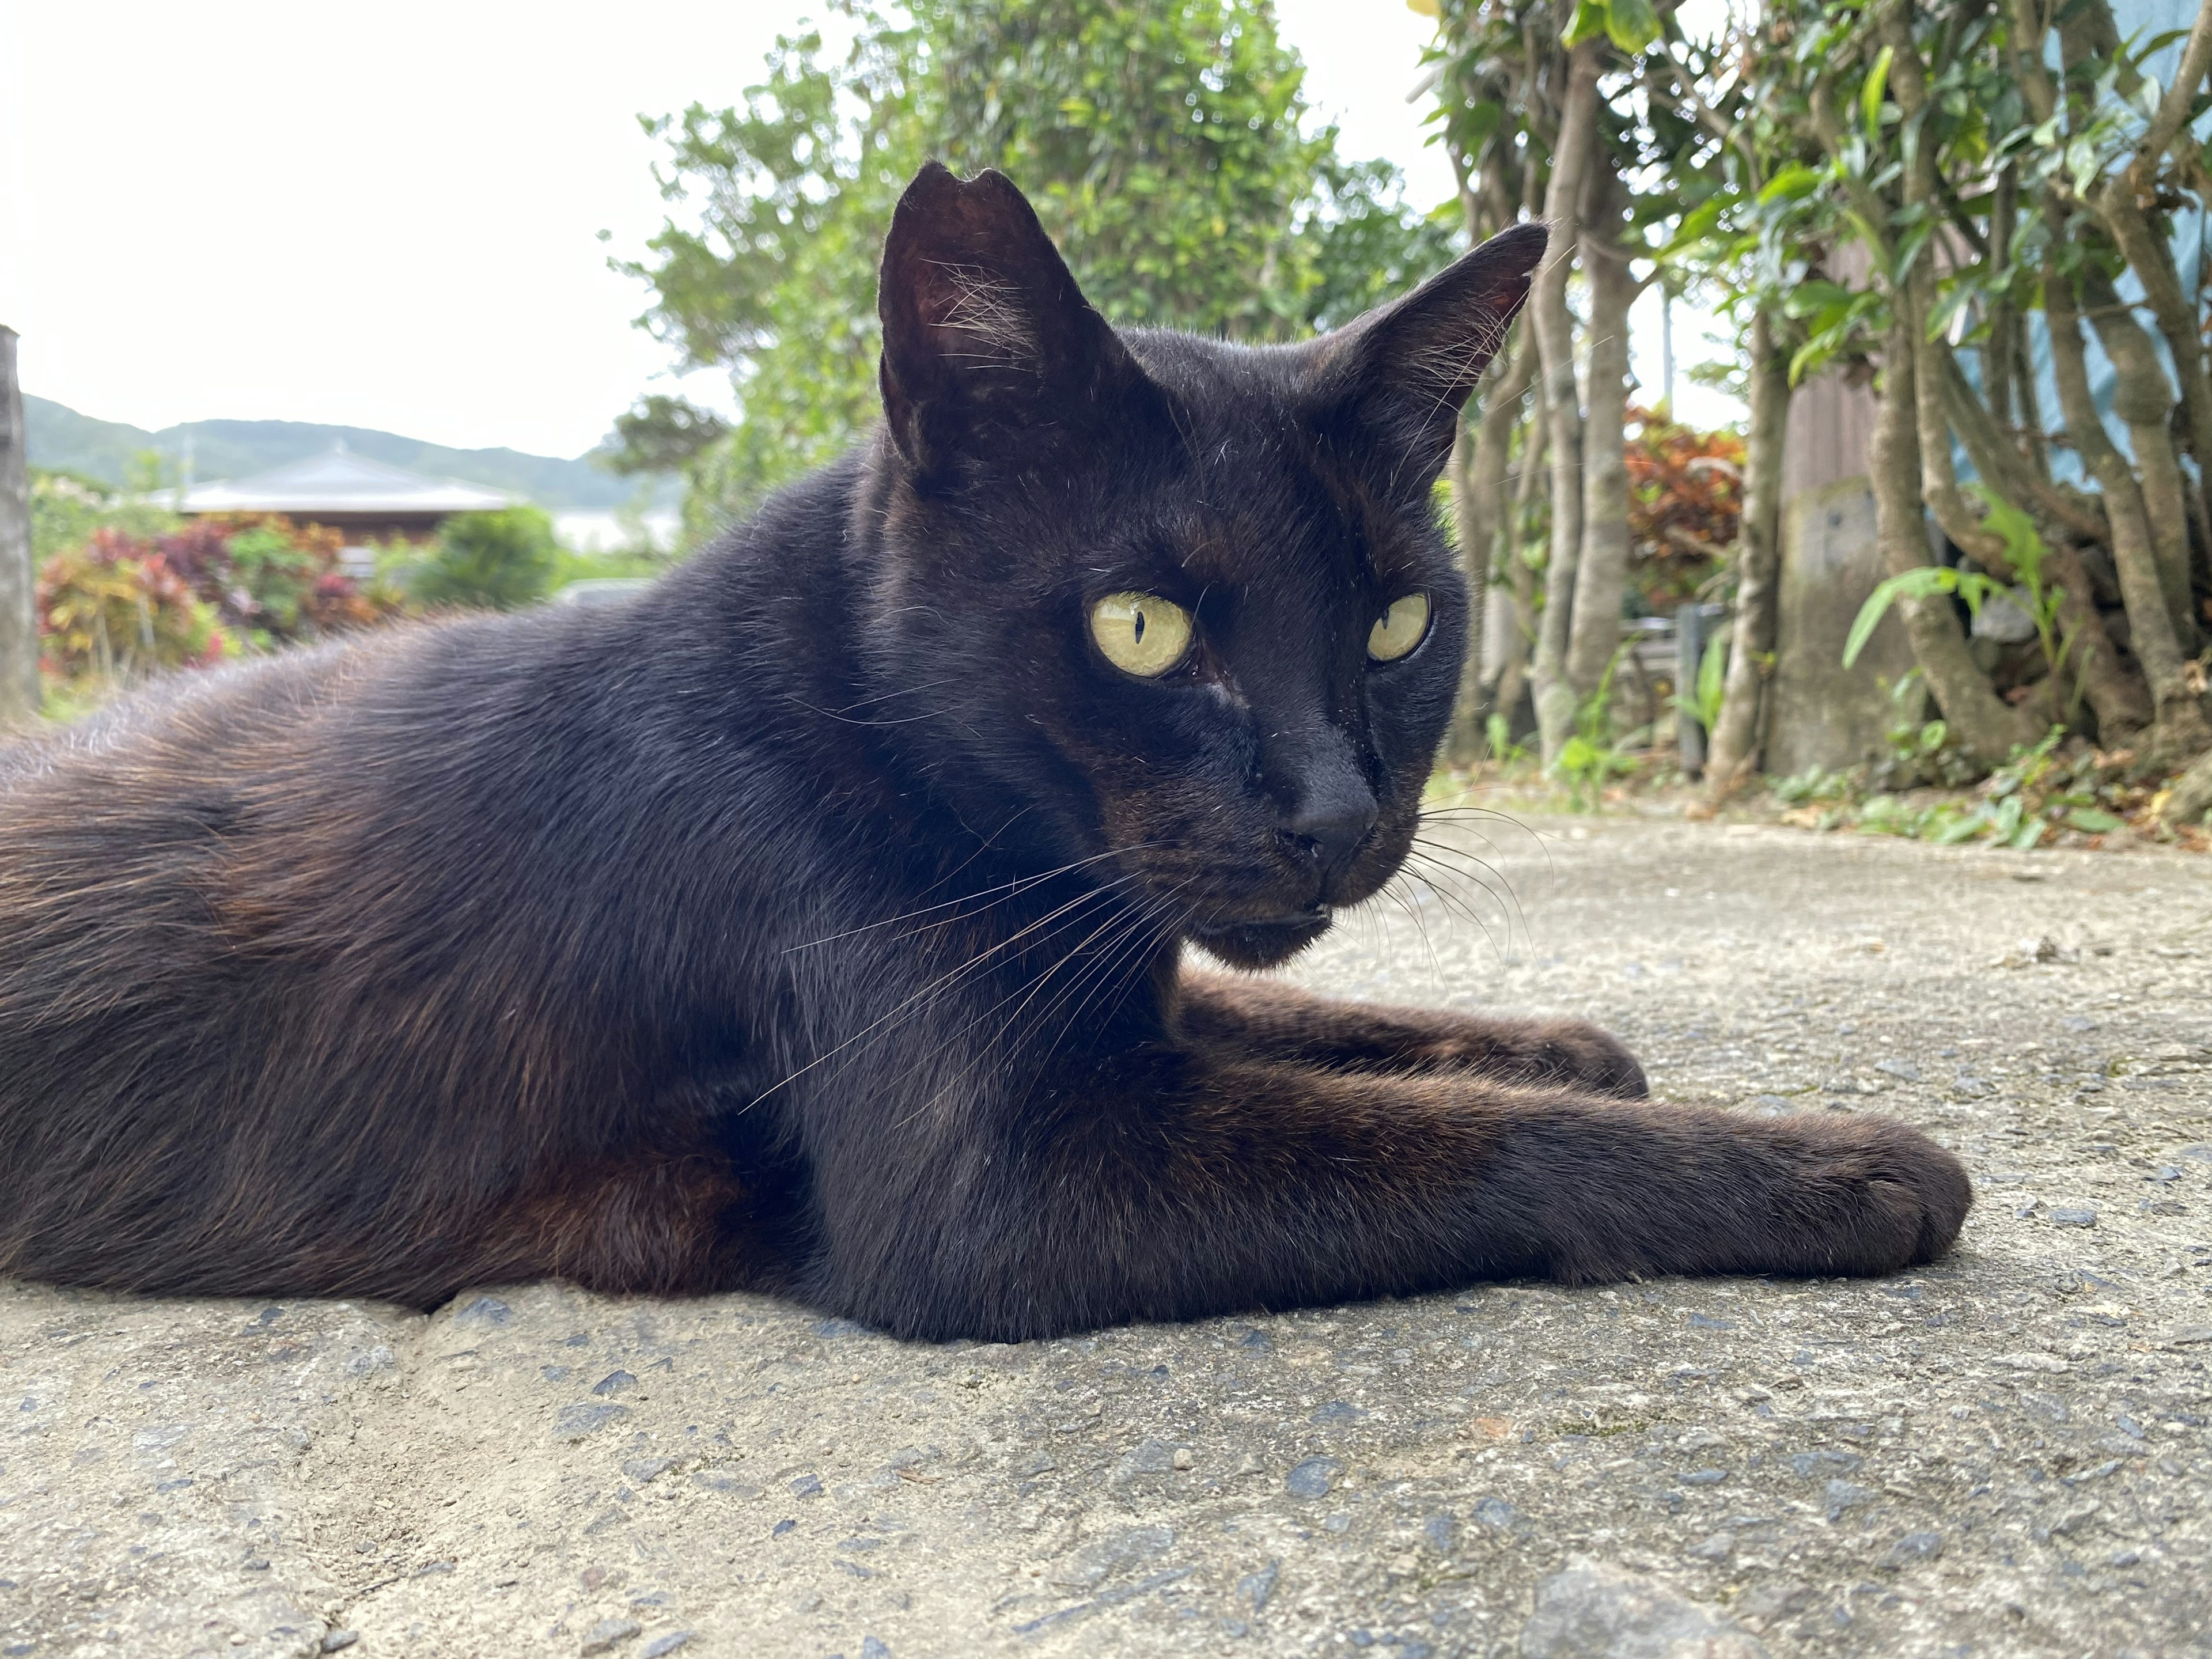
0, 166, 1971, 1338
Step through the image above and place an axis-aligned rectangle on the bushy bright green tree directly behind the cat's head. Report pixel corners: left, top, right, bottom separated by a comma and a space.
624, 0, 1456, 535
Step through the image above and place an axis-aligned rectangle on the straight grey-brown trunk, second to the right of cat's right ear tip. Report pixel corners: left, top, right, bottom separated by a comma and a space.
1566, 179, 1637, 701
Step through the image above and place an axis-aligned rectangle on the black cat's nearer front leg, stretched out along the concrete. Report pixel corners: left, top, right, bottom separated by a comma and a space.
808, 1046, 1973, 1340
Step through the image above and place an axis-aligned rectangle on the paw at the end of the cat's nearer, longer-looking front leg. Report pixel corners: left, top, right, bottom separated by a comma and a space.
1749, 1117, 1973, 1274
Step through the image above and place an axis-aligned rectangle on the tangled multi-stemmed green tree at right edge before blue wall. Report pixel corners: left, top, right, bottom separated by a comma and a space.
1677, 0, 2212, 766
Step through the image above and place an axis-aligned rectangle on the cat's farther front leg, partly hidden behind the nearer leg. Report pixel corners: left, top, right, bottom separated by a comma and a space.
1170, 974, 1650, 1099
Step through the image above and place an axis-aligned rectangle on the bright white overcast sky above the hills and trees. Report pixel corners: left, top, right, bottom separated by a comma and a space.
0, 0, 1725, 456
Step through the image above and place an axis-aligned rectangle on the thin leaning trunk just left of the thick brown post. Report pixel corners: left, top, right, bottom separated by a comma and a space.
1706, 312, 1790, 805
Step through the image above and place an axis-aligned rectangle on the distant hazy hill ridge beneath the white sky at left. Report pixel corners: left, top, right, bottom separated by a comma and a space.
22, 396, 681, 513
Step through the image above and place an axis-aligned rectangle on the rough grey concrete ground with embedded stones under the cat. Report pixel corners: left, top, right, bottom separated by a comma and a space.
0, 819, 2212, 1659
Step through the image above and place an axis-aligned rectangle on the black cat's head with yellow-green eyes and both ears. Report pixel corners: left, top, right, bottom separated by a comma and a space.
856, 166, 1546, 967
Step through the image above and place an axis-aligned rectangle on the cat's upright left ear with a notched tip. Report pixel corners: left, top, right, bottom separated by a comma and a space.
876, 161, 1143, 478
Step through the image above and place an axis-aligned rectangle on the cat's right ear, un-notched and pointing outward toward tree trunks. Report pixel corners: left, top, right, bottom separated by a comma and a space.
1316, 224, 1551, 500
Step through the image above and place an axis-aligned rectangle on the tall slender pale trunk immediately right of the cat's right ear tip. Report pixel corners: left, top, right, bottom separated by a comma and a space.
1528, 40, 1597, 766
